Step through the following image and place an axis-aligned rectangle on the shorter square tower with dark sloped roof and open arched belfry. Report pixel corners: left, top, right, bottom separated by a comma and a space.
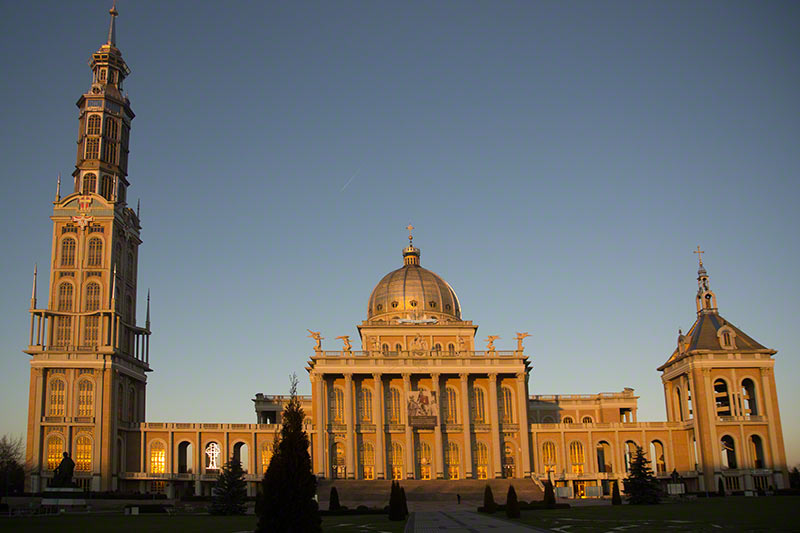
659, 246, 788, 492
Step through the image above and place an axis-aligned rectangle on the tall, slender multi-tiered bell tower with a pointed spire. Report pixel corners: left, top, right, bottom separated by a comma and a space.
25, 7, 150, 491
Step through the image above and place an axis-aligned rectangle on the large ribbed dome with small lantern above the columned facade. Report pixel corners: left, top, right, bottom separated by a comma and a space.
367, 246, 461, 322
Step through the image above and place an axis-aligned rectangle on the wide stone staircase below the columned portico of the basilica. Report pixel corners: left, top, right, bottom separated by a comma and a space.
317, 479, 544, 509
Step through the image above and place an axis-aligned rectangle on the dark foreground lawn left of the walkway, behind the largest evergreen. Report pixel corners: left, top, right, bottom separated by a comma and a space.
0, 514, 405, 533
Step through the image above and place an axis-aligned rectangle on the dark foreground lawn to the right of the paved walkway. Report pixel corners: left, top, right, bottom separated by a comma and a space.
520, 496, 800, 533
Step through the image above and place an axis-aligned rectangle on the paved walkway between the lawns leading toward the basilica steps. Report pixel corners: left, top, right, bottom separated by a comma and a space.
405, 511, 547, 533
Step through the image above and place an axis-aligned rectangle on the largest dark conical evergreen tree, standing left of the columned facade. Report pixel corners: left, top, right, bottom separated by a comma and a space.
256, 374, 322, 533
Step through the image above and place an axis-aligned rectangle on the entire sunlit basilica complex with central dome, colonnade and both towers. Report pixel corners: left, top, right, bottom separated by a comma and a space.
25, 8, 788, 498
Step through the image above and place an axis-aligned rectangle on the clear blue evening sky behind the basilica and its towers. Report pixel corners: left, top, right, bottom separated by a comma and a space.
0, 0, 800, 464
